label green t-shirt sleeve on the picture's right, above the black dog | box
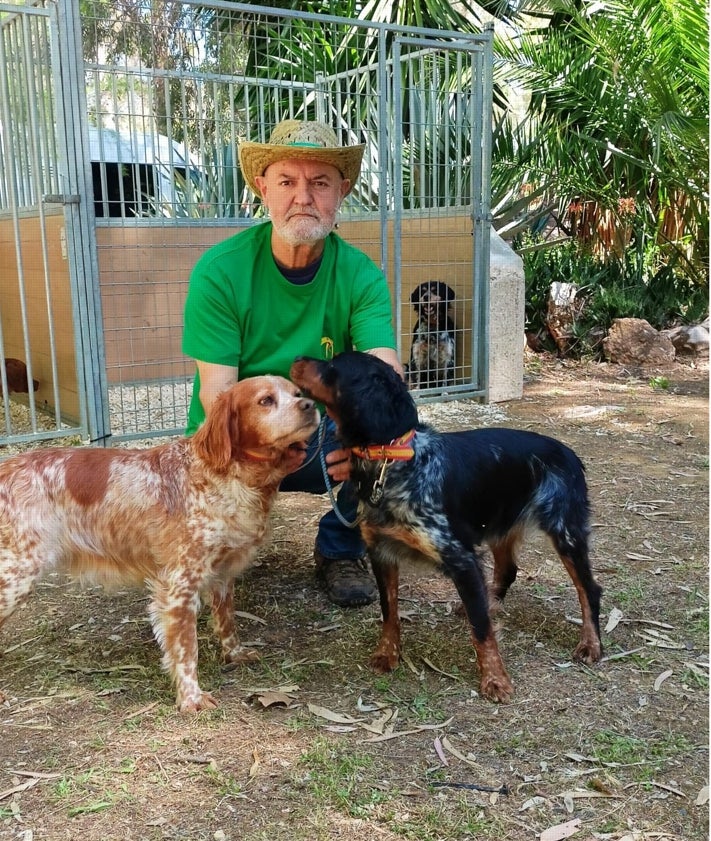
[350,255,397,351]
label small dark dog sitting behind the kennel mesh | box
[407,280,456,388]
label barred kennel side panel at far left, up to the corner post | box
[0,3,108,446]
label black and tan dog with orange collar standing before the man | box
[291,352,602,702]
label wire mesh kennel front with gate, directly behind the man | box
[0,0,491,446]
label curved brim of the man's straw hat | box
[238,141,365,198]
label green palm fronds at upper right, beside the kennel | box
[497,0,709,282]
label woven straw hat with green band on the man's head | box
[239,120,365,198]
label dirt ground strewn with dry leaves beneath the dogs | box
[0,357,709,841]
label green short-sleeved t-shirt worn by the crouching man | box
[183,222,396,434]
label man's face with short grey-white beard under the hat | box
[255,160,350,245]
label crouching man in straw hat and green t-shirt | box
[183,120,403,607]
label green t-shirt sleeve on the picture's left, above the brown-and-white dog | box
[182,259,242,367]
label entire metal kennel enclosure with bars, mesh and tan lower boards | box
[0,0,492,444]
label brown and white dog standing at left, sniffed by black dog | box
[0,376,319,712]
